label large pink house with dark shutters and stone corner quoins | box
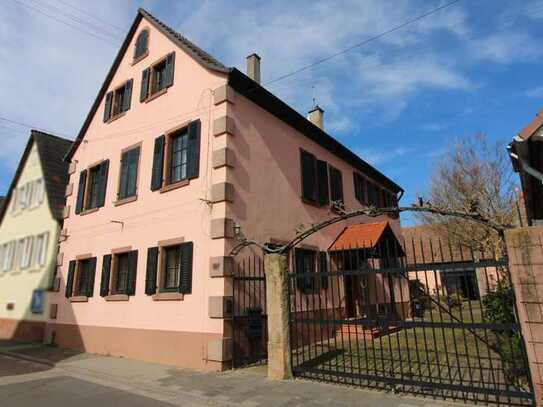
[46,9,402,370]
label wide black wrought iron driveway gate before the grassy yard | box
[289,242,533,405]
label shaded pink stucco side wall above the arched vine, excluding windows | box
[224,89,400,256]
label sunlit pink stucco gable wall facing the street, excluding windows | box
[49,20,230,342]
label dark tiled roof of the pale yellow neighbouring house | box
[0,130,72,222]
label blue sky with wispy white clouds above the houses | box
[0,0,543,223]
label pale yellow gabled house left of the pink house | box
[0,130,72,342]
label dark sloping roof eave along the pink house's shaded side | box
[228,68,403,193]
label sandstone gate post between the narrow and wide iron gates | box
[264,254,292,380]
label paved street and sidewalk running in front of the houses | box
[0,341,462,407]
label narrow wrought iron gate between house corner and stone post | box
[232,256,268,367]
